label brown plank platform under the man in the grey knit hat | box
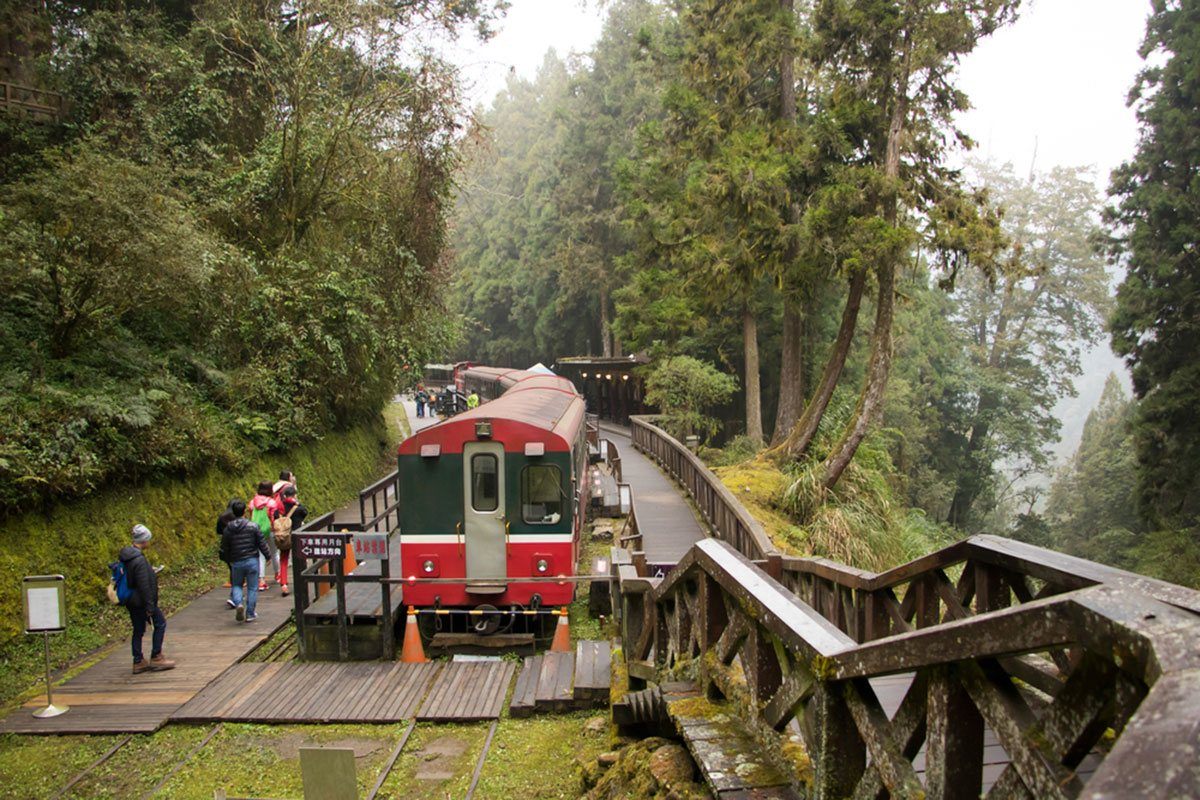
[0,585,292,734]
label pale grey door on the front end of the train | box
[462,441,508,594]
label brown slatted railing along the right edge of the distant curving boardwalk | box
[629,416,782,578]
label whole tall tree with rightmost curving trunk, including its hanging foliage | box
[814,0,1019,488]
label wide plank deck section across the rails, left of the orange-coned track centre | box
[172,662,440,723]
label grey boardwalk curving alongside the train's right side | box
[600,421,708,565]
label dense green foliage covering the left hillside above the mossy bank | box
[0,0,494,516]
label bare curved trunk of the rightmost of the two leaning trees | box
[824,34,912,489]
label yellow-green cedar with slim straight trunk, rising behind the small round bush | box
[640,0,794,441]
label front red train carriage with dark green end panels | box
[398,367,588,634]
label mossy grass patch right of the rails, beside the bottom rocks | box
[477,711,608,800]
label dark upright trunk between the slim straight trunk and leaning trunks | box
[770,0,804,446]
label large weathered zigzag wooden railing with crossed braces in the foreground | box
[616,536,1200,798]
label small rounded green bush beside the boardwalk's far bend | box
[646,355,738,438]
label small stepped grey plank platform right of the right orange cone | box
[509,640,612,717]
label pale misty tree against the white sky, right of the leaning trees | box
[944,163,1110,528]
